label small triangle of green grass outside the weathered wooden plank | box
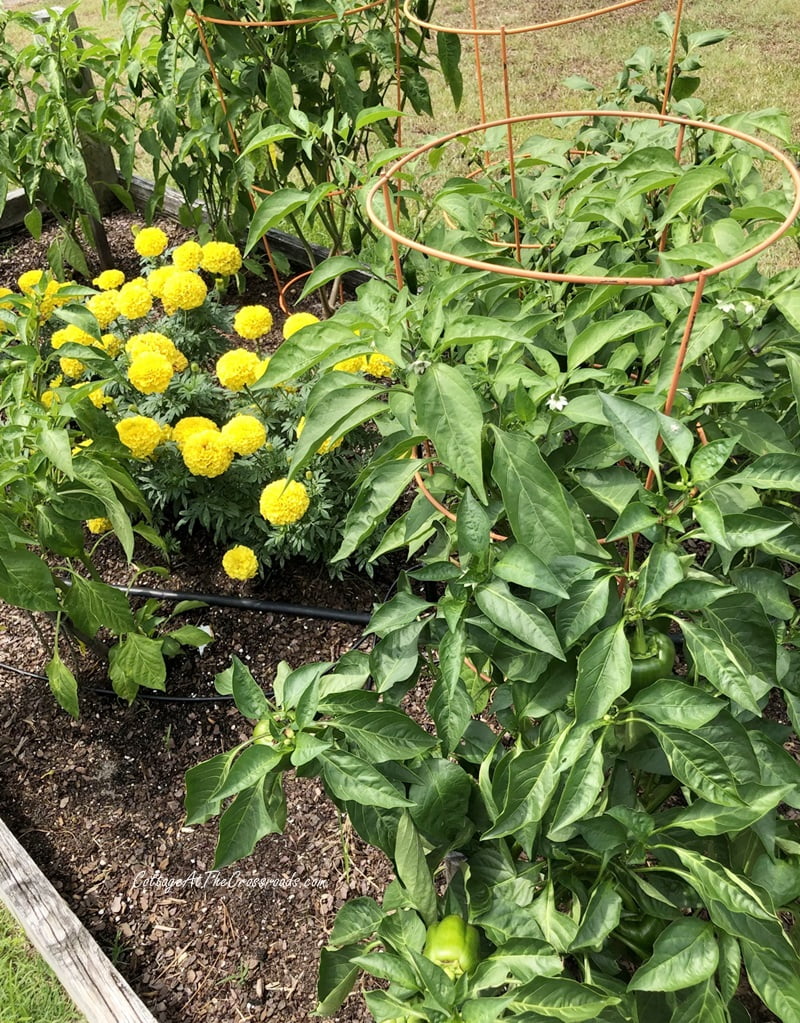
[0,903,84,1023]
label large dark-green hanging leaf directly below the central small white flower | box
[492,429,575,564]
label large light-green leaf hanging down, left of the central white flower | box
[414,363,486,502]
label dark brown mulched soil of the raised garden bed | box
[0,209,392,1023]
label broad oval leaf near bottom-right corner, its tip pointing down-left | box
[628,919,719,991]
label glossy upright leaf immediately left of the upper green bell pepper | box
[575,621,631,726]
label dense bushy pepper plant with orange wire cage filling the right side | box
[186,113,800,1023]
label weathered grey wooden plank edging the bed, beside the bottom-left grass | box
[0,818,158,1023]
